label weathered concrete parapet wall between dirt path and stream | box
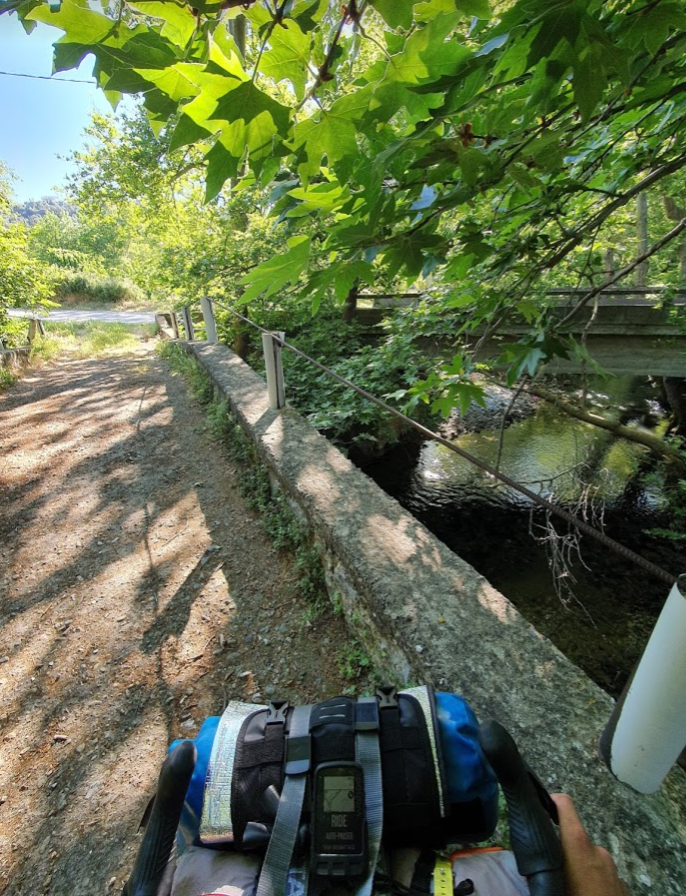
[182,343,686,896]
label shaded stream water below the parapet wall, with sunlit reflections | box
[365,377,686,695]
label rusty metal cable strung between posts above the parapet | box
[176,299,677,585]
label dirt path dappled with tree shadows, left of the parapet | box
[0,344,347,896]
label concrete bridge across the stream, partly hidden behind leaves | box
[357,287,686,378]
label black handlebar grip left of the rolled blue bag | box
[122,740,197,896]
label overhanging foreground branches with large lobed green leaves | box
[5,0,686,377]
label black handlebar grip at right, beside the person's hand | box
[479,721,565,896]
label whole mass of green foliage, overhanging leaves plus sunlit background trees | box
[3,0,686,456]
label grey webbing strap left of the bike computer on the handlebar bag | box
[256,706,312,896]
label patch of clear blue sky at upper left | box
[0,13,111,201]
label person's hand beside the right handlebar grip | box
[552,793,629,896]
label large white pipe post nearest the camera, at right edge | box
[600,576,686,793]
